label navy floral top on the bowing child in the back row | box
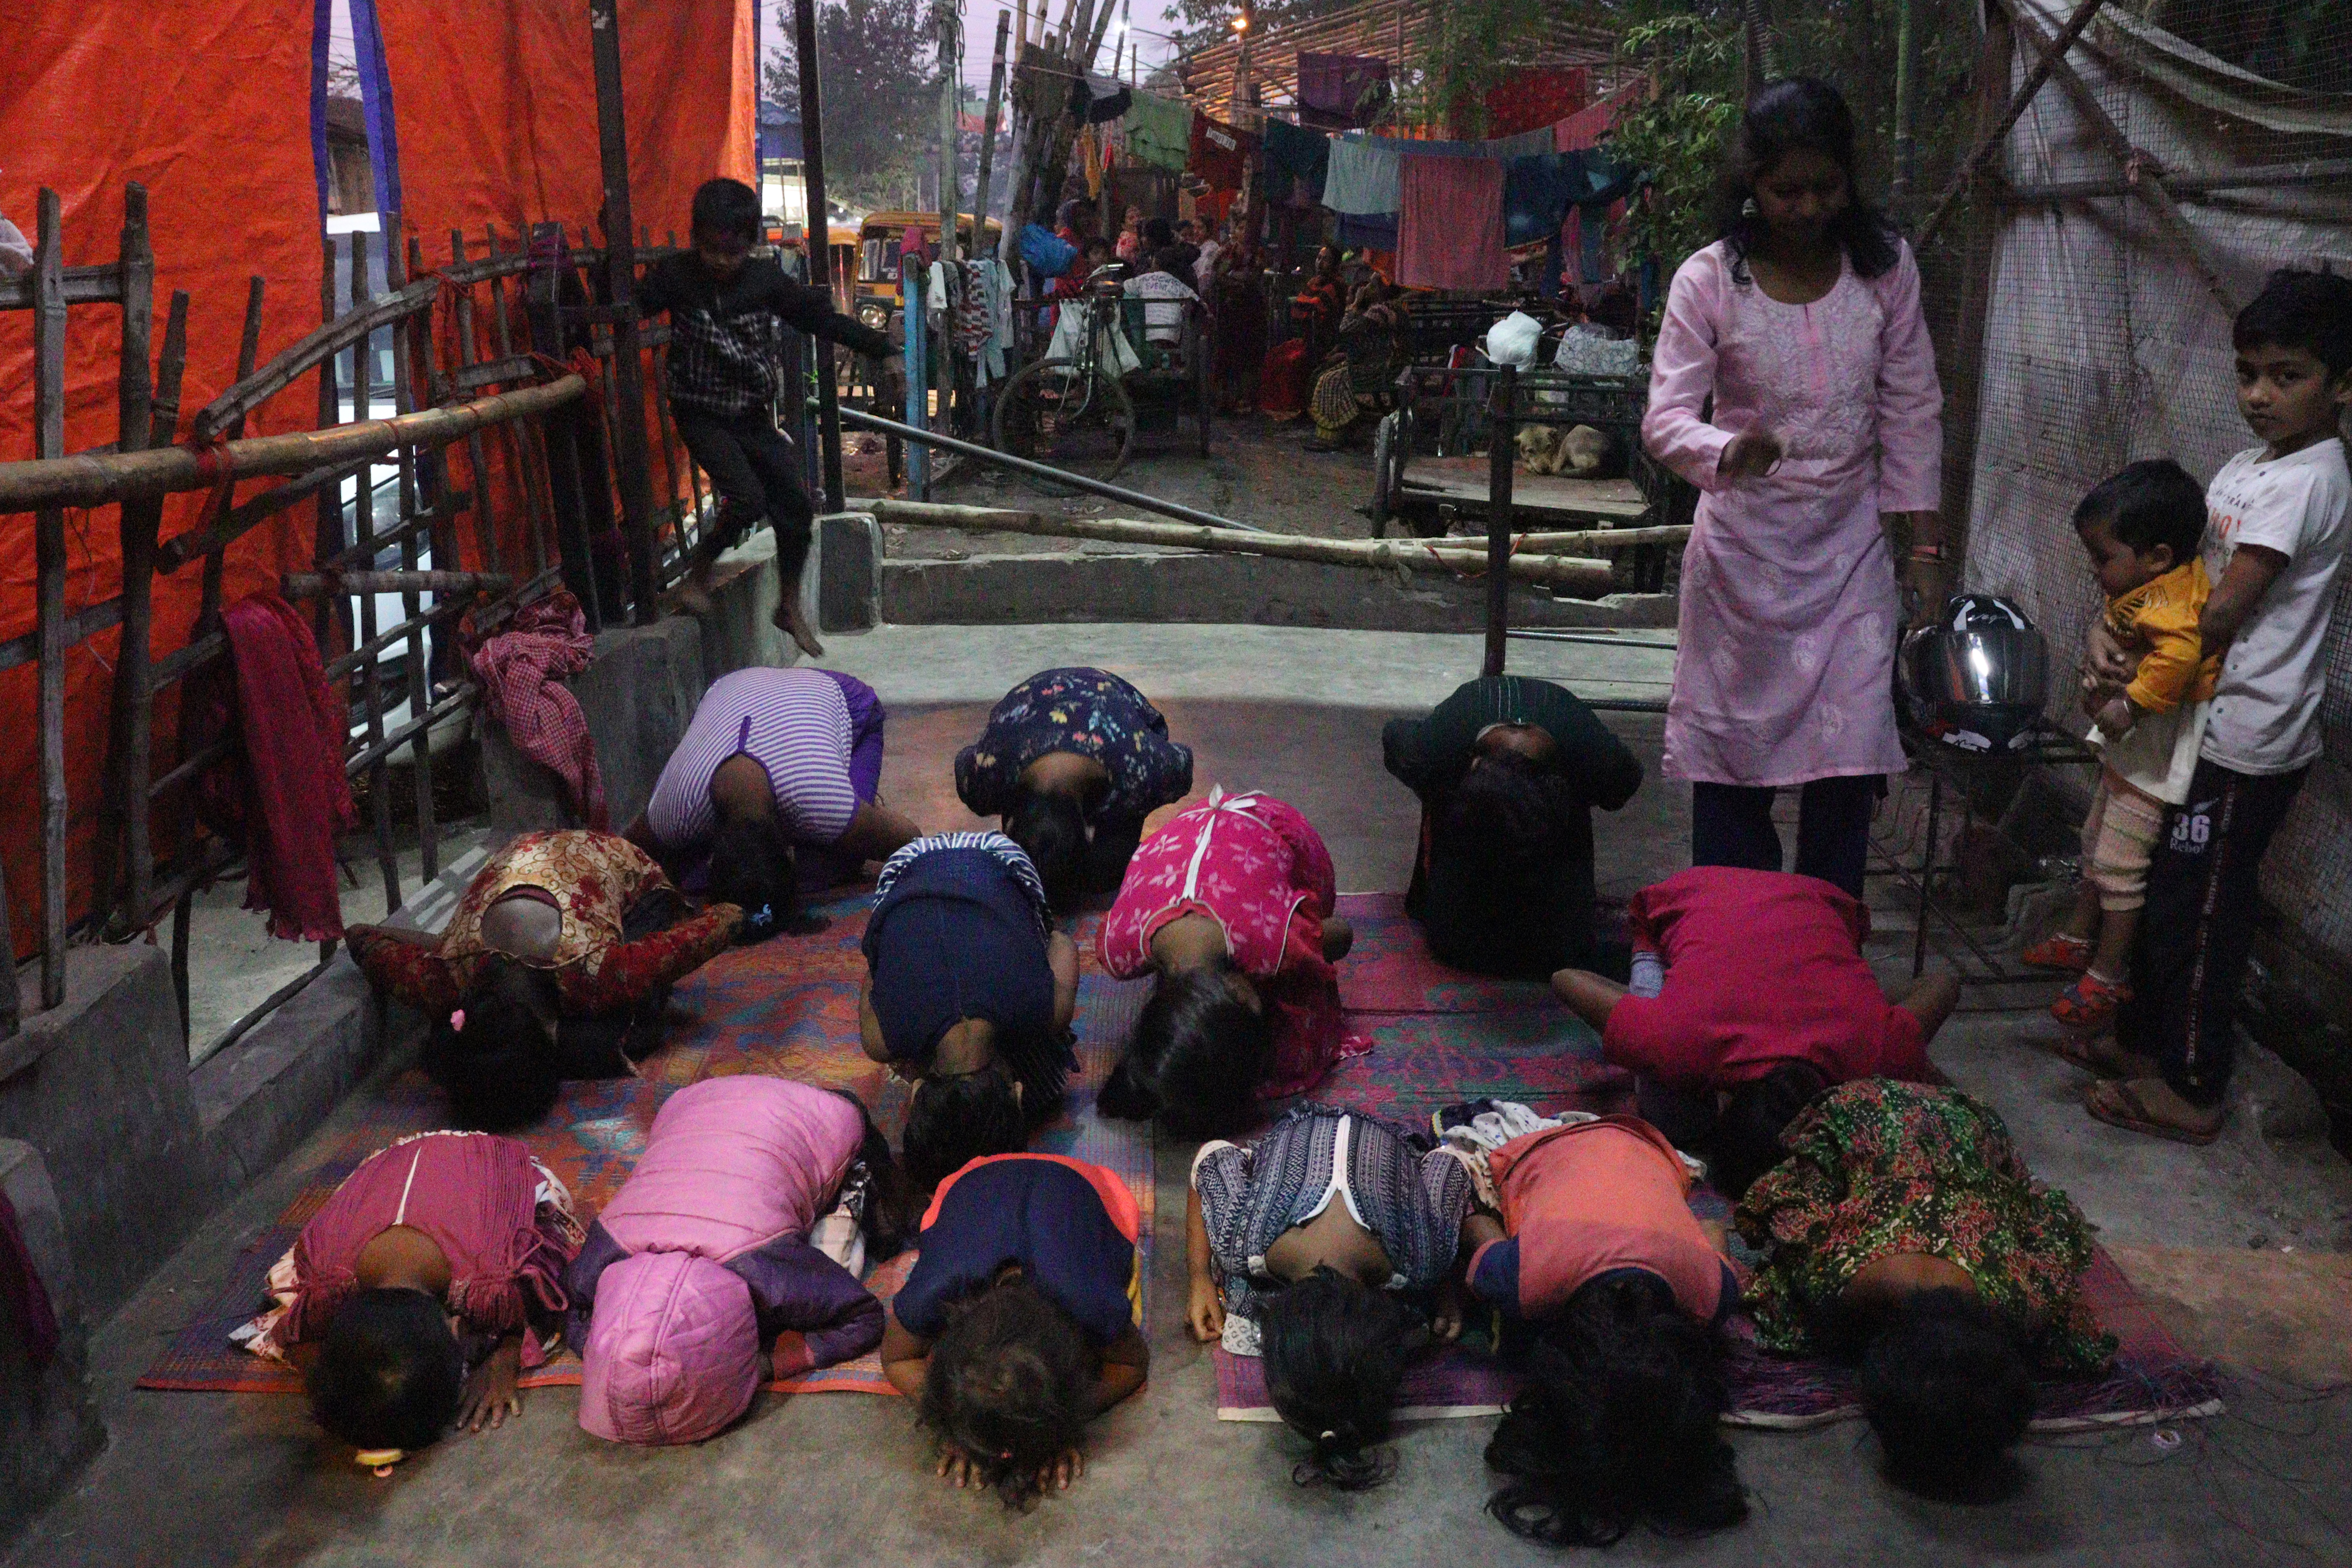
[955,668,1192,823]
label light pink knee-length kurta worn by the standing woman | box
[1642,242,1943,785]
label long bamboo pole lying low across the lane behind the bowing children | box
[851,498,1616,592]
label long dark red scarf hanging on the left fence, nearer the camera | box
[200,592,358,943]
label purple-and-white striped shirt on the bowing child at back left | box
[644,668,858,849]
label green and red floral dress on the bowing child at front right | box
[1736,1079,2114,1373]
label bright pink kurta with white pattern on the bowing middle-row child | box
[1096,790,1371,1100]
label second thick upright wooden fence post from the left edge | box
[89,181,162,931]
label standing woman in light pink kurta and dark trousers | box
[1642,78,1945,896]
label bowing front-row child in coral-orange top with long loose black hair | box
[1442,1103,1748,1547]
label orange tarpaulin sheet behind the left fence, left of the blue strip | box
[0,0,320,957]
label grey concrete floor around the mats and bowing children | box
[5,628,2352,1568]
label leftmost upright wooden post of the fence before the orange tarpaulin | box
[33,186,71,1009]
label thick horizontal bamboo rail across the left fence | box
[0,376,588,515]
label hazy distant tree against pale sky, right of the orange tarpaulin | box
[764,0,938,207]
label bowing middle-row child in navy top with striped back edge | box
[858,832,1077,1189]
